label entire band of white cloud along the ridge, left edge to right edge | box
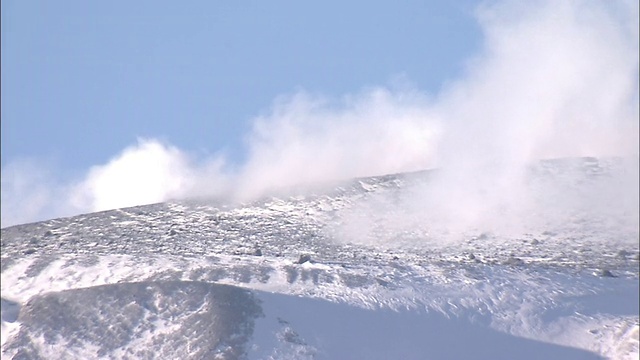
[2,0,640,227]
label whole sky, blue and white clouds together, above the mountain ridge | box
[1,0,638,227]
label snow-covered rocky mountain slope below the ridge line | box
[1,158,640,359]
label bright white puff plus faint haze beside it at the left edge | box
[2,139,228,227]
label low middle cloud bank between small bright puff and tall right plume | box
[240,88,440,196]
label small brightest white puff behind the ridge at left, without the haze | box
[71,139,230,211]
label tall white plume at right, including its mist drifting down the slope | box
[416,1,638,240]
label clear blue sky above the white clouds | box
[2,1,481,169]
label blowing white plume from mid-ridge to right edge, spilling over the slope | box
[234,1,638,242]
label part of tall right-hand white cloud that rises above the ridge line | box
[438,1,638,162]
